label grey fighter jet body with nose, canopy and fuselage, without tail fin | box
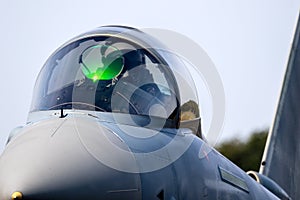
[0,18,299,200]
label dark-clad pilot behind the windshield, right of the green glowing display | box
[109,49,161,115]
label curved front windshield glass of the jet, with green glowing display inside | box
[31,36,180,119]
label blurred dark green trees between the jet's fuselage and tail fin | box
[217,131,268,171]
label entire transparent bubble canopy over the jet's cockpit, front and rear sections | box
[31,26,199,134]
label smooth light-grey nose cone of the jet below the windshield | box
[0,117,141,200]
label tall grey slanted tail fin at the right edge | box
[260,12,300,199]
